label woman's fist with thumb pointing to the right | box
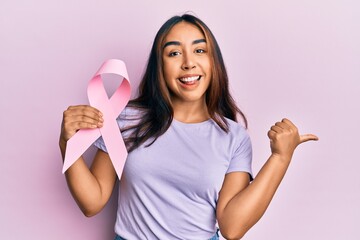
[268,118,318,160]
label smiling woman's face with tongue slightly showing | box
[162,22,211,103]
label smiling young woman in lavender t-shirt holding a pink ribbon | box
[60,15,317,239]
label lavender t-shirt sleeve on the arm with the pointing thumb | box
[226,129,253,180]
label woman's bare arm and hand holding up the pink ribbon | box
[59,106,116,217]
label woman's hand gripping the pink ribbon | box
[60,105,104,147]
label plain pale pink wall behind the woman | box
[0,0,360,240]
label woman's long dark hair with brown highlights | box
[123,14,247,152]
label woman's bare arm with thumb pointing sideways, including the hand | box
[216,119,318,239]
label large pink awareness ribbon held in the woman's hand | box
[62,59,131,179]
